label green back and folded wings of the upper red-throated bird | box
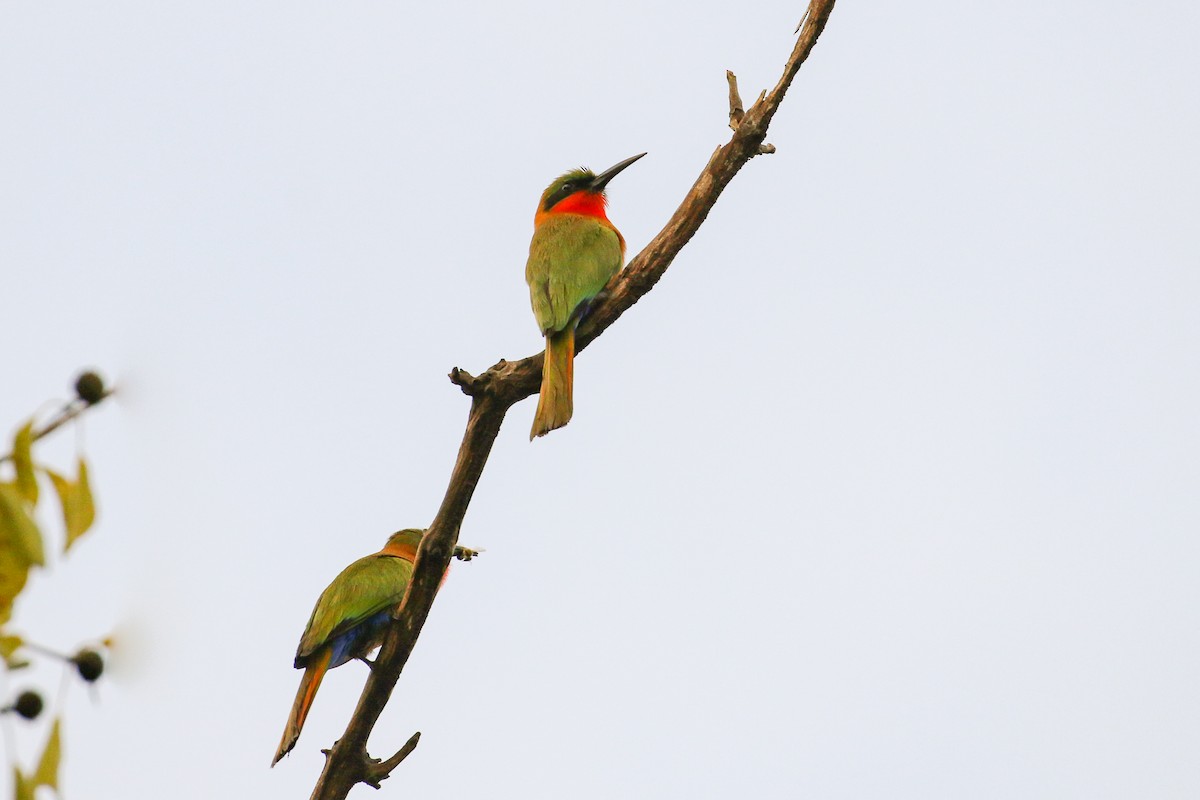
[526,213,622,333]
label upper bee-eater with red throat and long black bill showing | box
[526,152,646,439]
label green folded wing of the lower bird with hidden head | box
[296,553,413,660]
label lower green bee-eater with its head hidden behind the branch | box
[271,528,427,766]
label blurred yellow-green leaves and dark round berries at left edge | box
[0,372,110,800]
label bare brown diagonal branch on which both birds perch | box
[312,0,834,800]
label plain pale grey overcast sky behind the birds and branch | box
[0,0,1200,800]
